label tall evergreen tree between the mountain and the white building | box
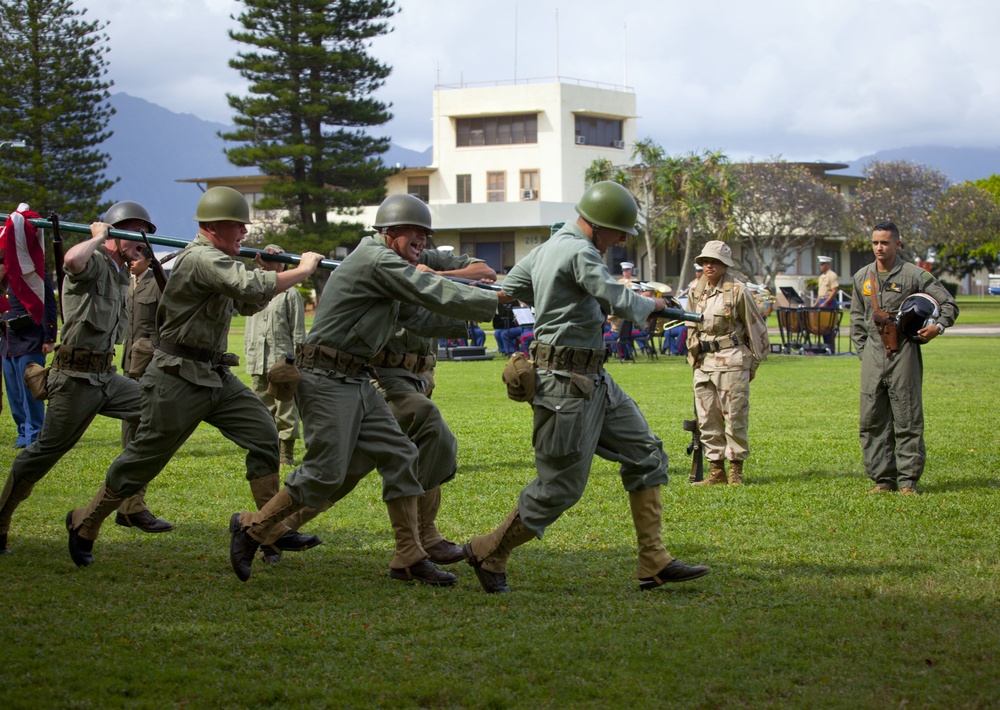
[222,0,396,252]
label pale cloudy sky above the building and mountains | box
[76,0,1000,160]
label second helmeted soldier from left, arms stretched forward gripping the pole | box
[66,187,323,567]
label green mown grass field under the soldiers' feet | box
[0,336,1000,708]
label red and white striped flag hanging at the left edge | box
[0,202,45,323]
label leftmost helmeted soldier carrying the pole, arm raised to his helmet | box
[0,202,173,551]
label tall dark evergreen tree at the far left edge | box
[0,0,117,222]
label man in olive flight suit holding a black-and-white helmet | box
[851,222,958,495]
